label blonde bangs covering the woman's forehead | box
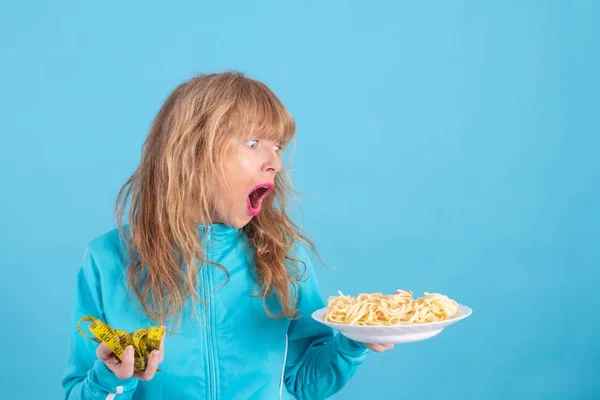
[224,79,296,147]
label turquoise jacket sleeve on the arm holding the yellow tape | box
[62,246,138,400]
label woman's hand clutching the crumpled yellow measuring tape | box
[96,335,165,381]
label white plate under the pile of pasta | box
[312,304,473,344]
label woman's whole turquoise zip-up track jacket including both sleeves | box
[62,224,369,400]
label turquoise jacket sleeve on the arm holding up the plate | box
[284,248,369,399]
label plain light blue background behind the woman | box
[0,0,600,400]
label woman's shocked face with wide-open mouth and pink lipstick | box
[213,138,282,228]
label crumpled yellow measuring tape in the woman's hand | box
[77,315,164,372]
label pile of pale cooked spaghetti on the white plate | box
[324,290,458,326]
